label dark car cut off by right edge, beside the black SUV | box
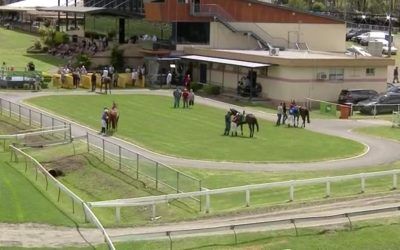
[357,92,400,115]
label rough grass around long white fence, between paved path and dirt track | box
[20,143,400,227]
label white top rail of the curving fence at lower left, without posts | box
[9,145,115,250]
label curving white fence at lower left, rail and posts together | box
[10,145,115,250]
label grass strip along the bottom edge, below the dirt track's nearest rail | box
[111,218,400,250]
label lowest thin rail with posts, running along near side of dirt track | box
[113,204,400,244]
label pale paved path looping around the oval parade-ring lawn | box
[0,90,400,171]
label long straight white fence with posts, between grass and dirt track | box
[89,169,400,220]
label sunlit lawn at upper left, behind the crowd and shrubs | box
[0,28,66,71]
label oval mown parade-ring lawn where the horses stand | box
[28,95,364,162]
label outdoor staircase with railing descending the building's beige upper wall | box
[190,3,289,50]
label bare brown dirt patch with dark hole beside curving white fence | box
[42,155,87,176]
